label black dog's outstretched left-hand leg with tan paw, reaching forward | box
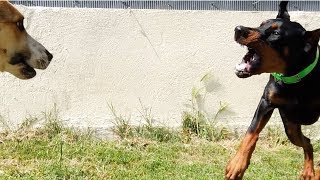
[225,97,274,179]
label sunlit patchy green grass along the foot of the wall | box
[0,106,312,180]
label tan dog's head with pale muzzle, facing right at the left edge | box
[0,0,52,79]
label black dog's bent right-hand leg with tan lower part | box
[279,108,314,180]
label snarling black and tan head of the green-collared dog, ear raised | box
[234,1,320,78]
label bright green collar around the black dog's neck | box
[271,48,319,84]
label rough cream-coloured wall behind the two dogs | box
[0,6,320,131]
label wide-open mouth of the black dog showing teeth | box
[235,47,261,78]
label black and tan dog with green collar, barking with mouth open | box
[225,1,320,179]
